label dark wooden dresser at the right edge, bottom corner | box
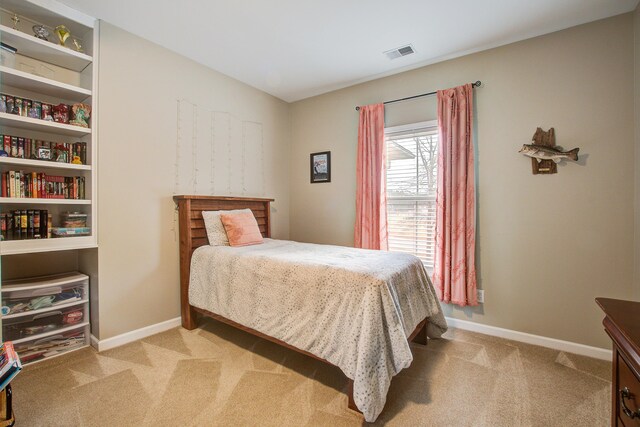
[596,298,640,427]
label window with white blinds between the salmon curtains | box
[385,121,438,270]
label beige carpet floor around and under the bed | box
[12,320,611,427]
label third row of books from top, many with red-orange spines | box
[0,171,86,200]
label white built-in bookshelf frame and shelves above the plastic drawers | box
[0,0,98,255]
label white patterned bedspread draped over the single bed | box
[189,239,447,422]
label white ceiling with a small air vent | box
[61,0,638,102]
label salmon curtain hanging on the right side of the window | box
[433,84,478,306]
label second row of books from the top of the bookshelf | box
[1,135,87,165]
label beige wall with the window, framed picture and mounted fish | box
[290,14,634,347]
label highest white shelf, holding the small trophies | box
[0,25,93,72]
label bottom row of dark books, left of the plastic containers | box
[0,209,53,240]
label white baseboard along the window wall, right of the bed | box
[446,317,612,360]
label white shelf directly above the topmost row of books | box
[0,65,91,102]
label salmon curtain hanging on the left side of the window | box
[354,104,389,250]
